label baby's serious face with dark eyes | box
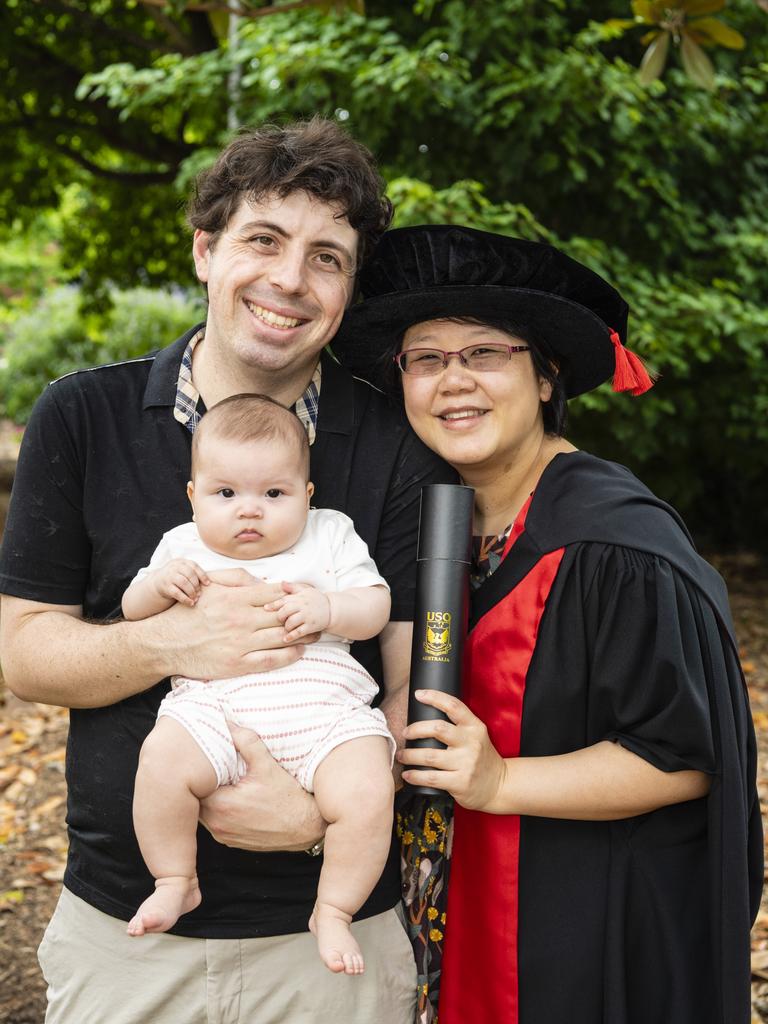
[187,436,313,559]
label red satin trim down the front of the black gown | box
[439,499,565,1024]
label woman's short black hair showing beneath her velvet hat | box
[385,316,568,437]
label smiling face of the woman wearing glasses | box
[401,319,552,480]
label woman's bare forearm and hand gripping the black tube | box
[397,690,711,820]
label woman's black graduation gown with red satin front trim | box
[439,453,763,1024]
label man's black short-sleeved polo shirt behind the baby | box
[0,329,455,938]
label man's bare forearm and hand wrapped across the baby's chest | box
[0,583,302,708]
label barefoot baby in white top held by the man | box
[123,394,395,974]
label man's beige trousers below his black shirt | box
[38,889,417,1024]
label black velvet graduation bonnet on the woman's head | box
[332,224,629,398]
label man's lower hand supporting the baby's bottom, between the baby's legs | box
[200,724,326,852]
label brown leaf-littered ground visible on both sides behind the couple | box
[0,432,768,1024]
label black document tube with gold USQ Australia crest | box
[407,483,475,795]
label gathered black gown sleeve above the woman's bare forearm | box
[585,547,728,773]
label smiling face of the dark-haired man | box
[193,193,357,374]
